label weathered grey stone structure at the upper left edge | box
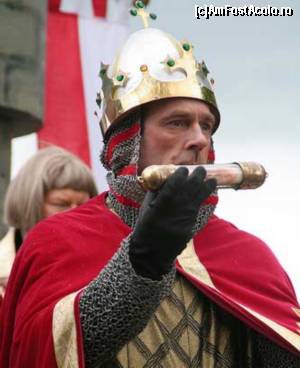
[0,0,47,236]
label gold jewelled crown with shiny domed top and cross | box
[97,1,220,135]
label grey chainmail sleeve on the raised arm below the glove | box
[79,236,175,368]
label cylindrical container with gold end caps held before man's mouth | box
[138,162,267,190]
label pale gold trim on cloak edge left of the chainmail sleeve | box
[52,291,79,368]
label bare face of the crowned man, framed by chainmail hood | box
[139,98,216,172]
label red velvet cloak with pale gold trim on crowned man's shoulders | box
[0,193,300,368]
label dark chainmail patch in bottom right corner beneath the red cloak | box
[253,332,300,368]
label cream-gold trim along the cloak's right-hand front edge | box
[177,240,300,351]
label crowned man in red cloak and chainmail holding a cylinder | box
[0,2,300,368]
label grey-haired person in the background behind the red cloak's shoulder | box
[0,147,97,300]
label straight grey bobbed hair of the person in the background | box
[4,146,97,236]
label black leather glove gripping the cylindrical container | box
[129,167,216,280]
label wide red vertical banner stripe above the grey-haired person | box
[38,12,90,165]
